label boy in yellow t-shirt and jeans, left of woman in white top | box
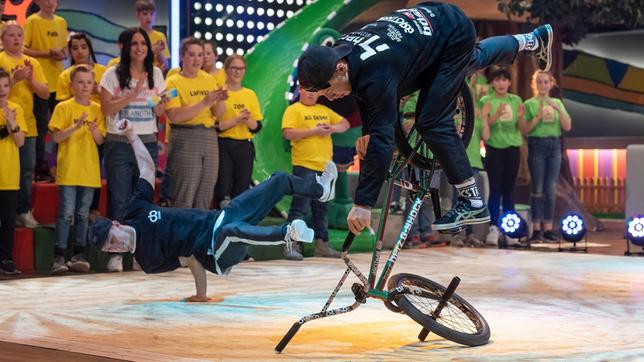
[49,65,106,274]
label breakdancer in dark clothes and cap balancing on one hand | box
[90,120,337,302]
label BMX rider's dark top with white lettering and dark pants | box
[336,3,519,207]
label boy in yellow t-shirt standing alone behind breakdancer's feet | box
[282,88,349,260]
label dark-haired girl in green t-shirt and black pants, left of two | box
[481,69,526,245]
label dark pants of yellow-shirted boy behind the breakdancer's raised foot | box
[288,166,329,241]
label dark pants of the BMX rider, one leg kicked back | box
[416,7,519,185]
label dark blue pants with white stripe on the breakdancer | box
[211,172,322,273]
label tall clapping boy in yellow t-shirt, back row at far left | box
[0,21,49,228]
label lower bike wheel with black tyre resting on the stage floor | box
[388,273,490,347]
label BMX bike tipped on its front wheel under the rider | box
[275,82,490,353]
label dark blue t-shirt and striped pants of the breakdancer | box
[122,172,323,274]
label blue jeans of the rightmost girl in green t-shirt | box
[528,137,561,223]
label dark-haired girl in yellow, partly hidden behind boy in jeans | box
[56,33,107,104]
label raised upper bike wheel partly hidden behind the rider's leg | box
[395,81,474,170]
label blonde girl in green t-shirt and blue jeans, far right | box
[524,70,571,242]
